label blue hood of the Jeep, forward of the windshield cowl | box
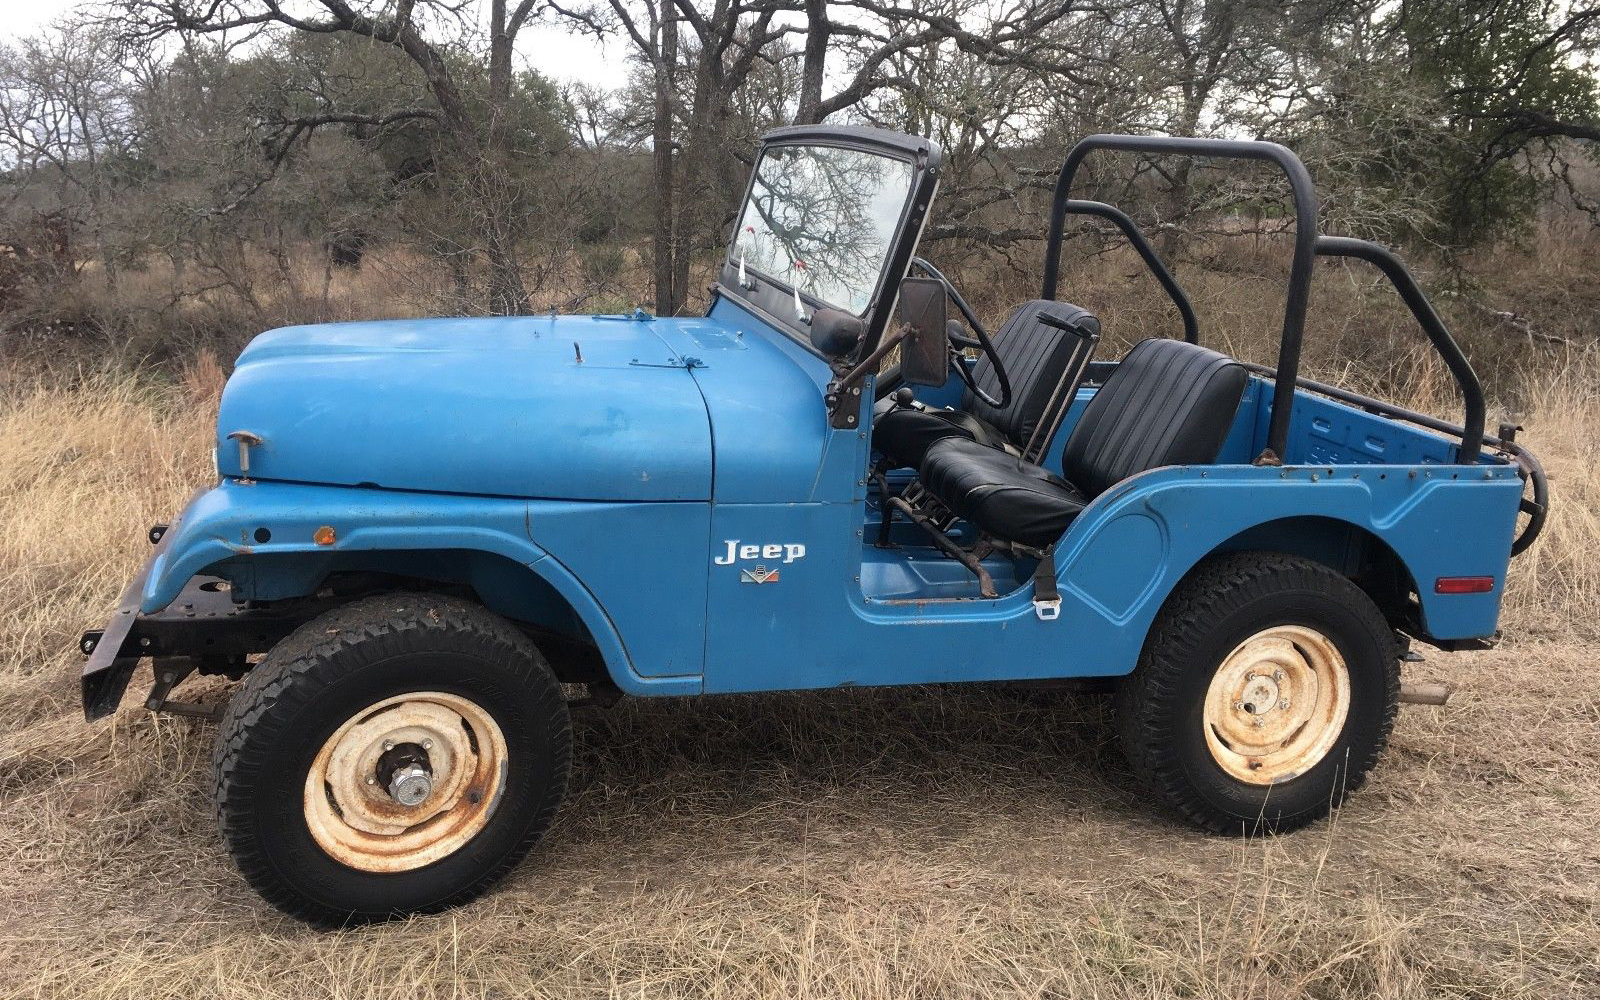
[218,317,712,501]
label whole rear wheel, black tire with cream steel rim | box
[1117,552,1400,834]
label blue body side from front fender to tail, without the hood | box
[142,388,1522,693]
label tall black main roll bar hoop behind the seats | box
[1038,134,1317,464]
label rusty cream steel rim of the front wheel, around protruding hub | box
[304,691,507,872]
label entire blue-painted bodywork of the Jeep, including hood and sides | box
[142,302,1522,694]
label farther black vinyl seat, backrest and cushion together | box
[872,299,1099,469]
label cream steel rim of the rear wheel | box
[1205,626,1350,786]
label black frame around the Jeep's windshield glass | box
[712,125,942,362]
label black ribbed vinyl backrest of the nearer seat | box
[1061,339,1250,499]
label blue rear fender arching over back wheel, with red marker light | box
[1056,466,1522,640]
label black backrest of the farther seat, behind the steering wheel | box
[962,299,1099,448]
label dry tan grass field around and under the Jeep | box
[0,312,1600,1000]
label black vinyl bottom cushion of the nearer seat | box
[920,437,1088,549]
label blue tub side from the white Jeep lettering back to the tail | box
[706,466,1522,691]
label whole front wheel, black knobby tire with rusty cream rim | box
[213,594,571,925]
